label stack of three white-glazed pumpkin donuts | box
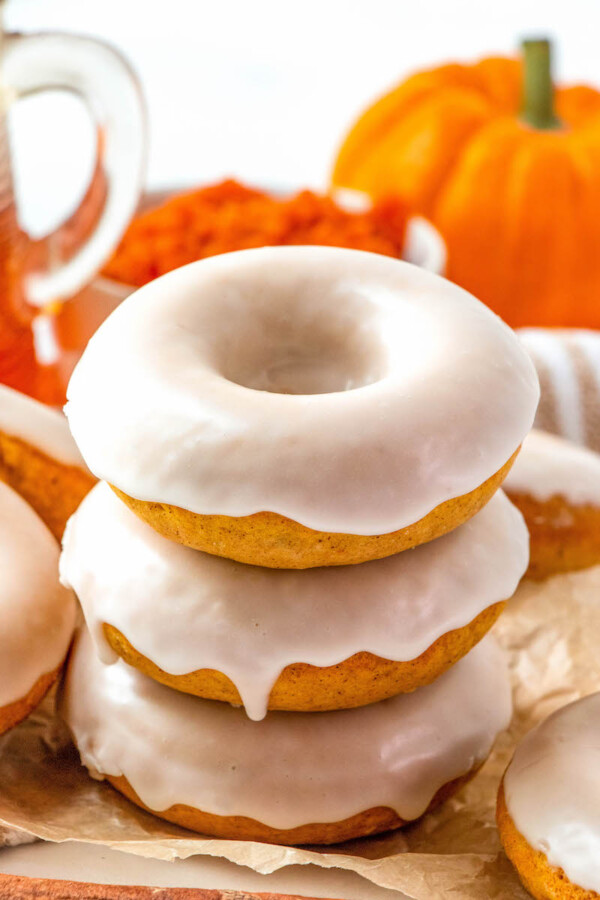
[61,247,538,844]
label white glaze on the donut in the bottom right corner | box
[504,693,600,893]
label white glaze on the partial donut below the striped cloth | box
[504,431,600,506]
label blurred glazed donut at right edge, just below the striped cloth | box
[505,431,600,580]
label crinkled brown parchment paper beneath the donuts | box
[0,567,600,900]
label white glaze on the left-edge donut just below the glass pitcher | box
[0,384,85,467]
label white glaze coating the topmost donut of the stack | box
[66,247,538,534]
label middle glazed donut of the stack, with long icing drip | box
[60,484,528,719]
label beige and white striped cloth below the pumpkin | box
[517,328,600,452]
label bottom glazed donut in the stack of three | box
[60,631,511,844]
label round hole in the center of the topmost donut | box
[220,298,387,394]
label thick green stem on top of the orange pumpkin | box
[521,39,561,129]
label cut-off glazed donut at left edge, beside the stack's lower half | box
[0,482,76,734]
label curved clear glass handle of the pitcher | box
[3,32,146,307]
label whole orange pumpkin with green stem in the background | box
[332,41,600,328]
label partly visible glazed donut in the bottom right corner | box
[497,693,600,900]
